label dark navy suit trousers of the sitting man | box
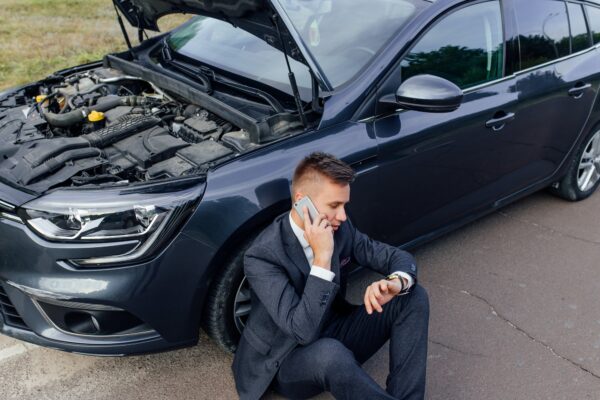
[274,285,429,400]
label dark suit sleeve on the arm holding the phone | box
[244,242,339,345]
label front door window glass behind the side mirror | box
[401,1,504,89]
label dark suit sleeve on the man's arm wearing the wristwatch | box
[347,220,417,283]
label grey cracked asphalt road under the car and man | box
[0,193,600,400]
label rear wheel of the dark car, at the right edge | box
[550,129,600,201]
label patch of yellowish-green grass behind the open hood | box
[0,0,189,91]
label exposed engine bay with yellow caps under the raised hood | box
[0,67,297,192]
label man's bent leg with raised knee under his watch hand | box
[323,285,429,400]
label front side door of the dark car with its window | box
[373,0,517,243]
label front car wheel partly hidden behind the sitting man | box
[203,243,251,353]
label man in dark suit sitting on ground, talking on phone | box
[232,153,429,399]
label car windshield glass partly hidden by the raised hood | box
[167,0,431,94]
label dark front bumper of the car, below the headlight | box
[0,205,209,355]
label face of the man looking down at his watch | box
[295,178,350,231]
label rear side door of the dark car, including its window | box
[507,0,600,194]
